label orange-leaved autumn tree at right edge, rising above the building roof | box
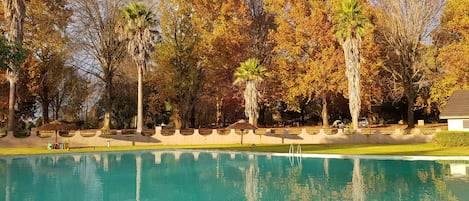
[430,0,469,110]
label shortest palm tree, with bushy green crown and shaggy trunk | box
[234,59,269,126]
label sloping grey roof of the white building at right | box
[440,90,469,119]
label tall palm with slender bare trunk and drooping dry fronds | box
[120,2,155,133]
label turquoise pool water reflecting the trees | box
[0,150,469,201]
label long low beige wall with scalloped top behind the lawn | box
[0,127,439,147]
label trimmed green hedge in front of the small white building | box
[435,131,469,147]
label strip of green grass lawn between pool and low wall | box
[0,143,469,156]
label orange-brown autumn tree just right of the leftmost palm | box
[24,0,72,123]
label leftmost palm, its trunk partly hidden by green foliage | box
[3,0,26,131]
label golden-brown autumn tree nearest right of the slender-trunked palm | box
[150,0,206,128]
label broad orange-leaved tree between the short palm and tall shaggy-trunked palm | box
[266,1,344,127]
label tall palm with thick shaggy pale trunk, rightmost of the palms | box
[335,0,368,129]
